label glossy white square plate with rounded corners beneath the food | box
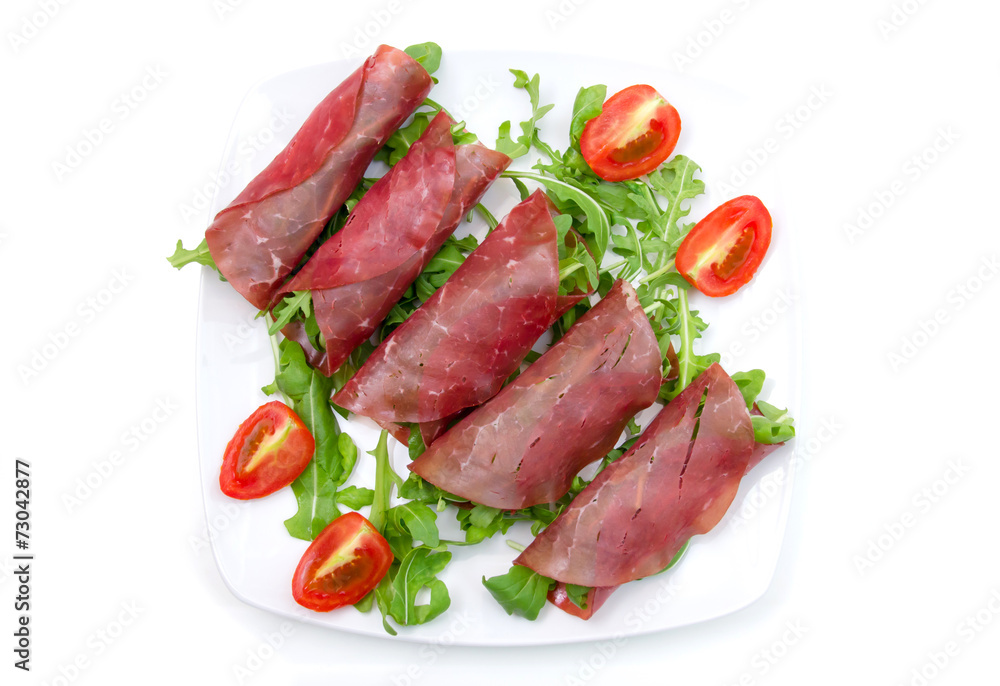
[197,52,800,646]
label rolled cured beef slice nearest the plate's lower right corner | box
[514,364,754,586]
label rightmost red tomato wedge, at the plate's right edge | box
[676,195,771,298]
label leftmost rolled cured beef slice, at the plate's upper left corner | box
[205,45,432,309]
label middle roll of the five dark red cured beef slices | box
[333,191,583,444]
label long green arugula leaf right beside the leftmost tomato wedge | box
[265,340,358,541]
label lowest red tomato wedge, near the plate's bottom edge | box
[292,512,392,612]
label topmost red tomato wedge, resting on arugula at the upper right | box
[580,84,681,181]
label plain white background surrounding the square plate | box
[0,0,1000,686]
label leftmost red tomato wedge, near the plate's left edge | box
[219,400,316,500]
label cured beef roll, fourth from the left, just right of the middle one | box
[409,281,661,510]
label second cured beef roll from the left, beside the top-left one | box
[278,113,510,376]
